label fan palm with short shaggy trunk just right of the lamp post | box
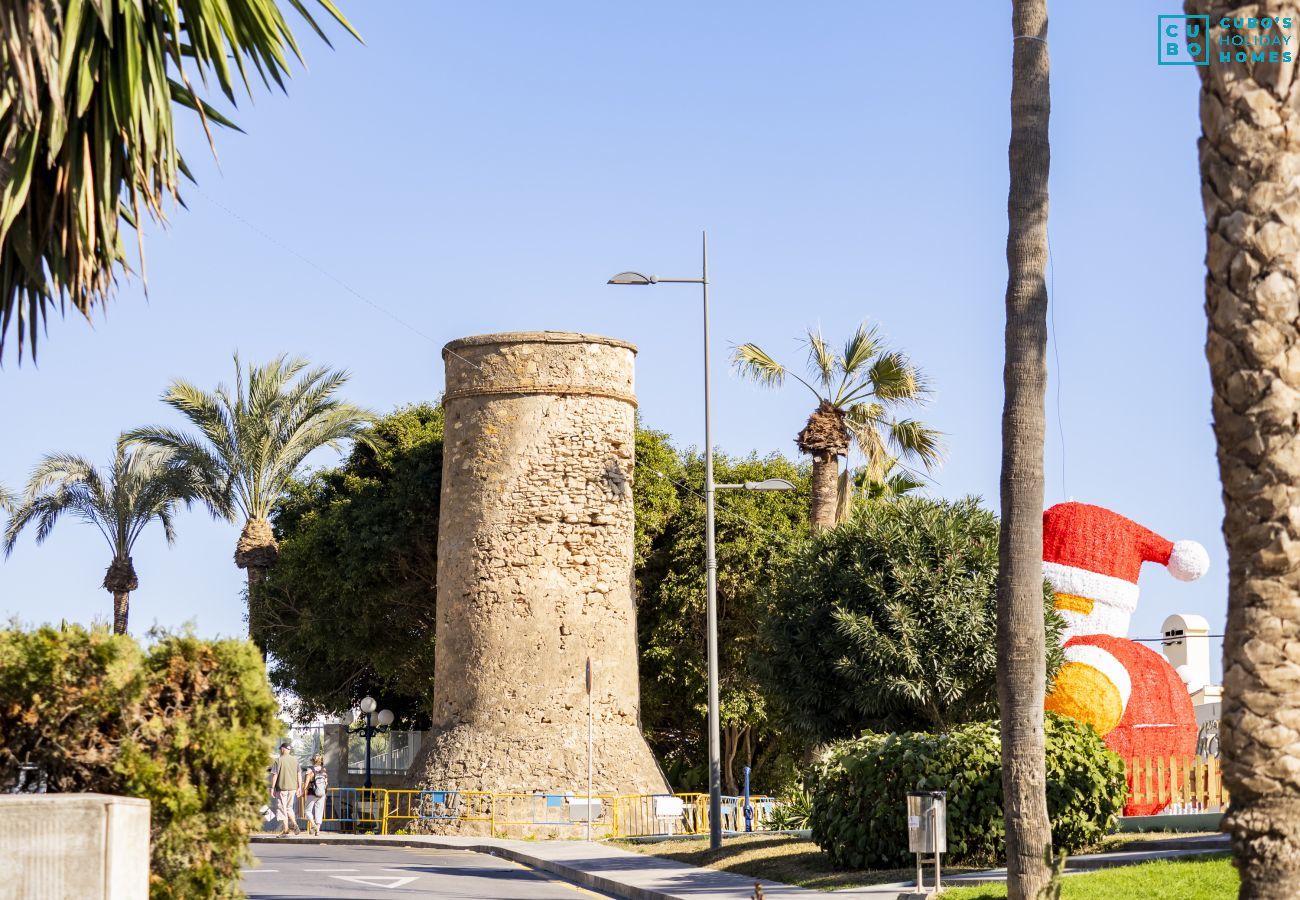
[732,324,941,532]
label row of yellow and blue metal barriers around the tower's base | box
[294,788,779,838]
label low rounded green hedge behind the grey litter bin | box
[810,714,1127,869]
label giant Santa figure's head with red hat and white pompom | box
[1043,503,1209,636]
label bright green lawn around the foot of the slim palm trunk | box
[943,854,1240,900]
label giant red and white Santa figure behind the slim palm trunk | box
[1043,503,1209,815]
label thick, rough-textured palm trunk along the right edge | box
[1187,0,1300,900]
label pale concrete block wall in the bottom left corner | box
[0,793,150,900]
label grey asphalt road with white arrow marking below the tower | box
[243,843,606,900]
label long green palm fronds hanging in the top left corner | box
[0,0,356,355]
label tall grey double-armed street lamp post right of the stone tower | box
[607,232,794,849]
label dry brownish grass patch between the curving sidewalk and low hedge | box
[615,835,971,896]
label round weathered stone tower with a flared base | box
[423,332,668,793]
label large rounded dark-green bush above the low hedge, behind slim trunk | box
[758,497,1062,743]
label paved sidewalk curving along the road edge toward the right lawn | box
[252,832,1227,900]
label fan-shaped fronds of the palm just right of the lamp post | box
[732,324,943,480]
